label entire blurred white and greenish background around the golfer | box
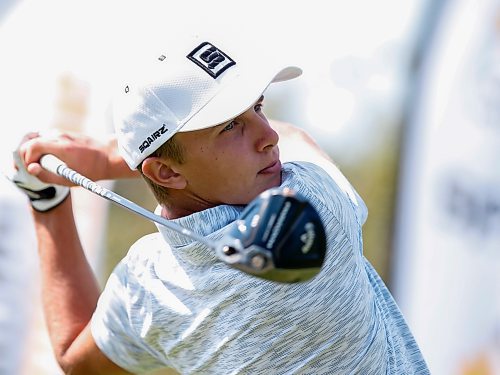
[0,0,500,375]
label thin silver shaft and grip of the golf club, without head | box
[40,155,215,249]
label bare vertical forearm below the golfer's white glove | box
[33,197,99,368]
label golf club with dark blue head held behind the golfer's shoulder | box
[40,155,326,283]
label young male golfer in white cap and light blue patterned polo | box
[10,33,428,375]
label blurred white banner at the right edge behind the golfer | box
[393,0,500,375]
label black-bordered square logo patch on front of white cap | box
[187,42,236,78]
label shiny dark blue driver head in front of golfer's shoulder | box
[218,188,326,283]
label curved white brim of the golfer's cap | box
[182,66,302,132]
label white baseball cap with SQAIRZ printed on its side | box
[113,36,302,169]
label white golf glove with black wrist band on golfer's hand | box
[9,150,69,212]
